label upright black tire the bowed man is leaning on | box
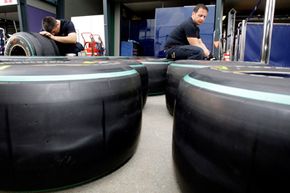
[4,32,60,56]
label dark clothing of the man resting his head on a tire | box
[56,19,77,56]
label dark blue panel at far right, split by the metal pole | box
[245,23,290,67]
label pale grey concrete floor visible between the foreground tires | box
[0,95,180,193]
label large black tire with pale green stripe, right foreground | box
[173,66,290,193]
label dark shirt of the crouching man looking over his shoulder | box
[164,17,200,49]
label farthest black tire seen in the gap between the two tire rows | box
[140,59,171,96]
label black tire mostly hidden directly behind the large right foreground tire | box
[165,60,262,115]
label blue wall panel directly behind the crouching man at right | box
[154,5,215,57]
